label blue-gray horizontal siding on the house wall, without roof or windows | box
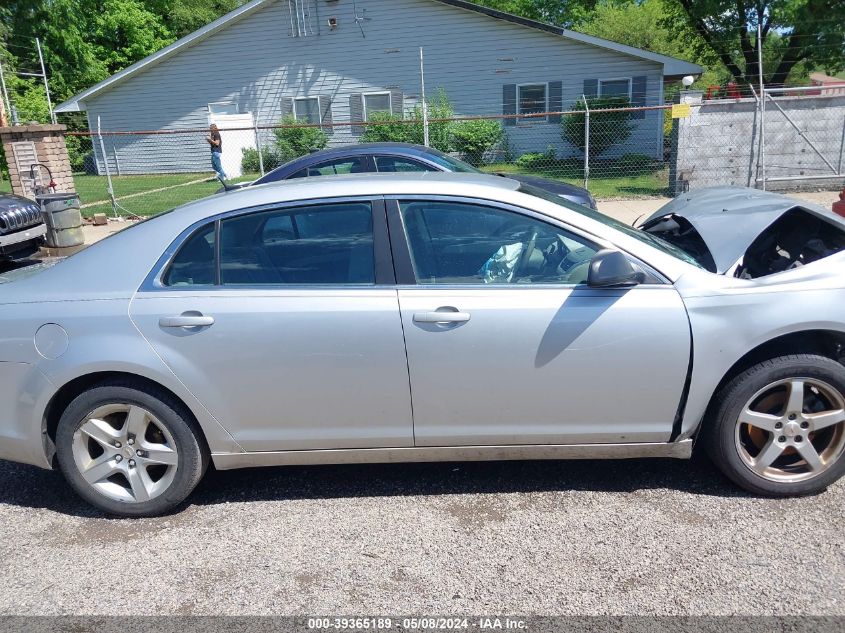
[85,0,663,173]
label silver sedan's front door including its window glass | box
[388,198,690,446]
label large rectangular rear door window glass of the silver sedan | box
[220,202,375,285]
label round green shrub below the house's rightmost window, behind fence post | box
[561,97,634,157]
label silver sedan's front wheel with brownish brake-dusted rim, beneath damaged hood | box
[701,354,845,497]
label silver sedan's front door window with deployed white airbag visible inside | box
[400,201,599,285]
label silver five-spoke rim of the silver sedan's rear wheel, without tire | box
[73,403,179,503]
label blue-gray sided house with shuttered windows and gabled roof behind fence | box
[56,0,701,173]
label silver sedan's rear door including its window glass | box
[130,199,413,451]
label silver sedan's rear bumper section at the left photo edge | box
[0,361,56,468]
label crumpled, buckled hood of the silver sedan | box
[639,187,845,278]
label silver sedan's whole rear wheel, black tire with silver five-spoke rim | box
[56,382,209,517]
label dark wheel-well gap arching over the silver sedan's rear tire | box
[43,371,208,467]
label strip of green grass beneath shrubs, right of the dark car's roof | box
[482,163,669,199]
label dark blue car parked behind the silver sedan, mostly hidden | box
[237,143,596,209]
